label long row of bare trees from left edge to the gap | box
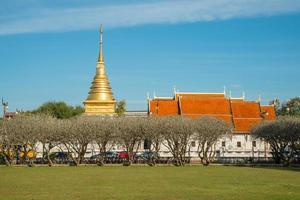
[0,115,231,166]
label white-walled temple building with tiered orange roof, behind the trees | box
[148,90,276,162]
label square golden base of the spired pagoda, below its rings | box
[84,101,116,116]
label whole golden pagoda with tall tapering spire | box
[83,25,116,115]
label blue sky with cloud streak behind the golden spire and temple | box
[0,0,300,111]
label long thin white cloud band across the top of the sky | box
[0,0,300,35]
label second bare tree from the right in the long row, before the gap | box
[161,117,193,166]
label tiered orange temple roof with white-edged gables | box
[149,92,276,133]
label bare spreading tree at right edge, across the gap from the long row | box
[252,117,300,165]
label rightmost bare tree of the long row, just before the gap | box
[194,117,231,166]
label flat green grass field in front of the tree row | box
[0,166,300,200]
